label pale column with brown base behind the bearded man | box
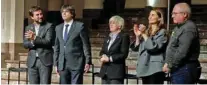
[1,0,24,60]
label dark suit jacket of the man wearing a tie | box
[54,21,91,70]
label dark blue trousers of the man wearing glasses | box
[171,64,201,84]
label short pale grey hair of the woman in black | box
[109,15,124,30]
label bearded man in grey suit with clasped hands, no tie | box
[23,6,54,84]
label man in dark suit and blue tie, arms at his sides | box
[54,5,91,84]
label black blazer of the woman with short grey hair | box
[100,32,130,79]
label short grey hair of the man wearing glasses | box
[175,3,191,18]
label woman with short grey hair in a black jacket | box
[100,16,130,84]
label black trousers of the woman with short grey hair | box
[102,76,124,84]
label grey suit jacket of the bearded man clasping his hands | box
[23,22,54,67]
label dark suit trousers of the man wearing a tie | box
[59,65,83,84]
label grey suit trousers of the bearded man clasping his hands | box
[28,58,52,84]
